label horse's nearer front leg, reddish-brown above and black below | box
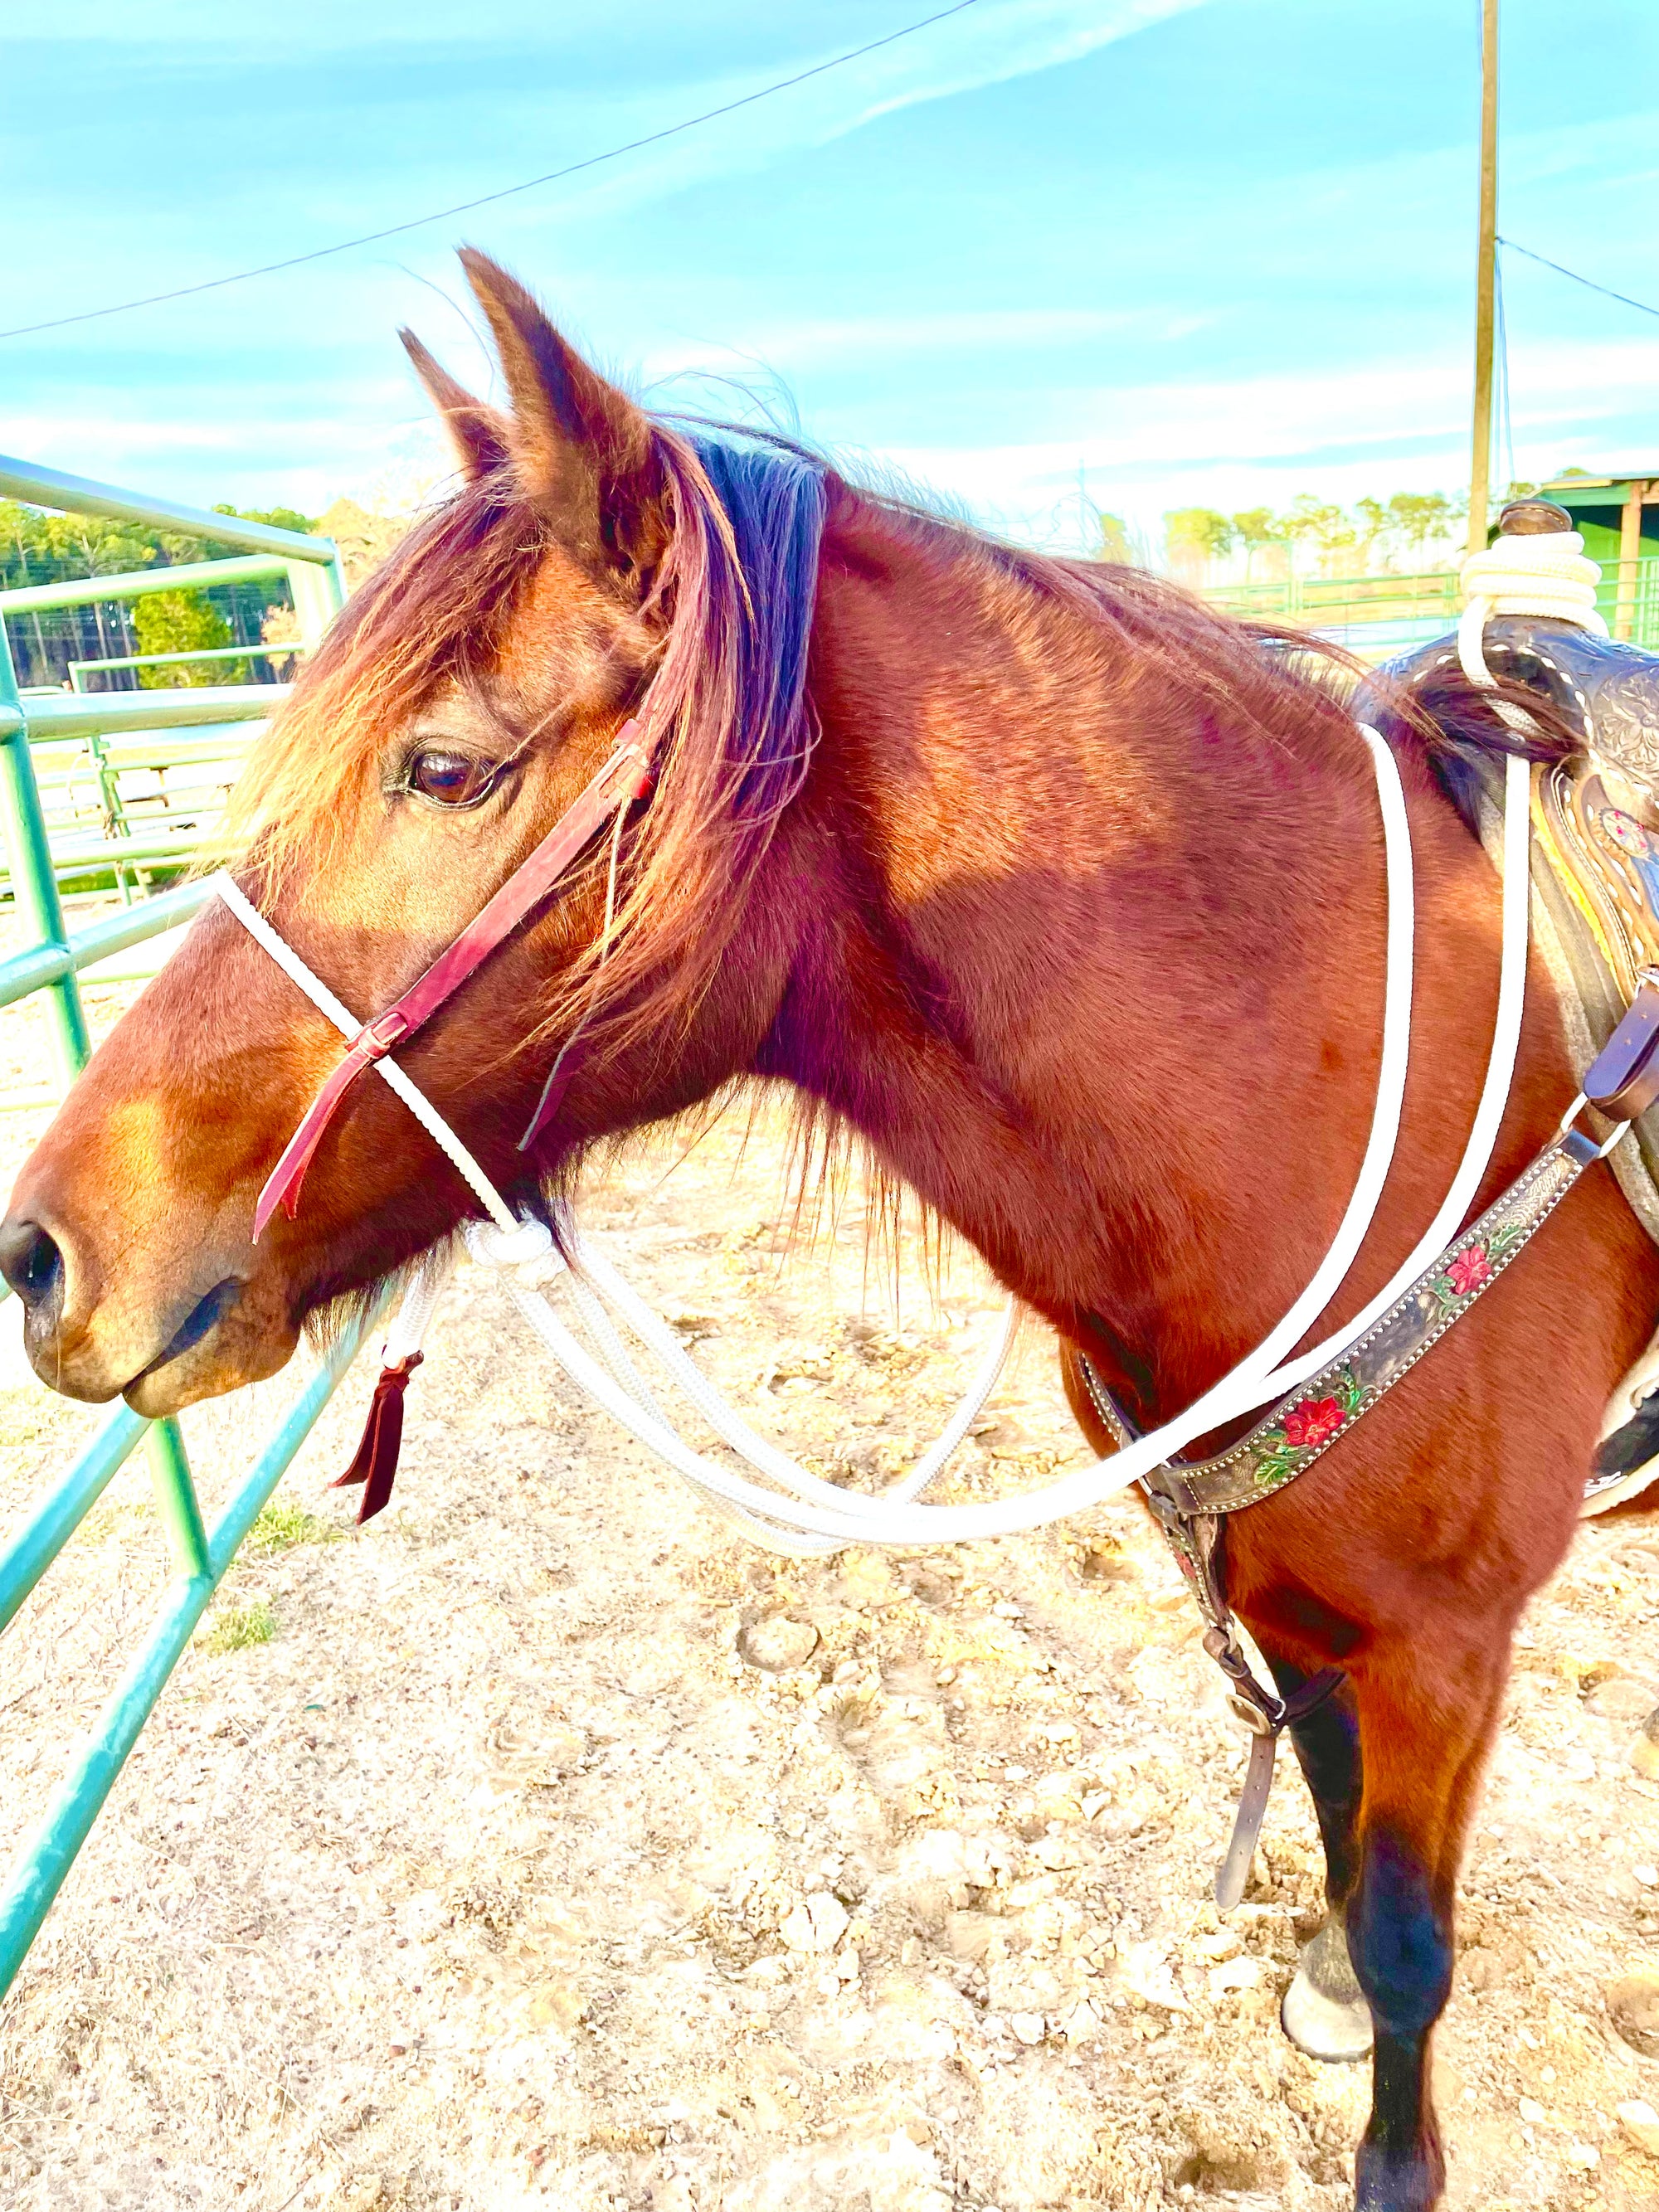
[1347,1650,1504,2212]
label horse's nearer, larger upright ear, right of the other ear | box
[460,246,666,577]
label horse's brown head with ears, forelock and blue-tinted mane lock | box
[0,255,823,1416]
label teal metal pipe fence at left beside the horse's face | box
[0,460,367,1996]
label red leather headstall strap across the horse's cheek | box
[255,721,654,1239]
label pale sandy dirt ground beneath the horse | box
[0,955,1659,2212]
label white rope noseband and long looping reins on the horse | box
[212,694,1529,1555]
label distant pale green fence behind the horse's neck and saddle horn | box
[1205,560,1659,659]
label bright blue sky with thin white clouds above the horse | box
[0,0,1659,542]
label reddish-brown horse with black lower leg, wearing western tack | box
[0,256,1659,2212]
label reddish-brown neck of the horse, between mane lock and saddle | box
[757,498,1570,1398]
